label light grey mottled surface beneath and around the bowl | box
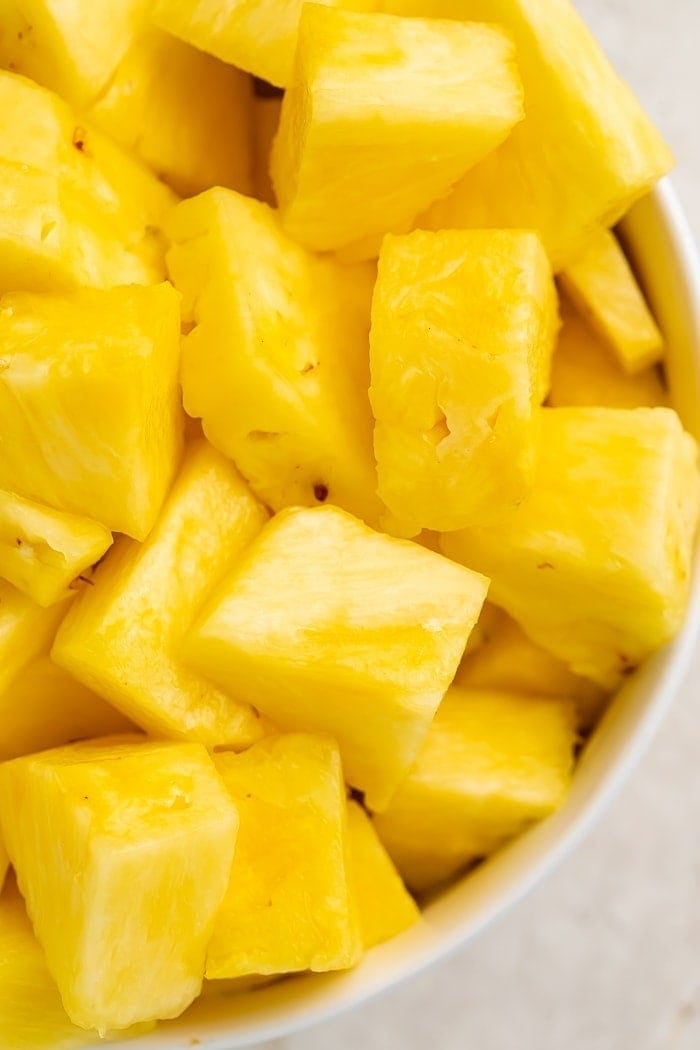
[266,0,700,1050]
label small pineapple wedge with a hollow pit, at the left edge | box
[0,491,112,605]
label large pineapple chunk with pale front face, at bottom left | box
[0,737,238,1031]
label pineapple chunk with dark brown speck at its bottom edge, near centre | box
[168,189,380,523]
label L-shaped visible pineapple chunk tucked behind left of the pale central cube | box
[52,441,268,748]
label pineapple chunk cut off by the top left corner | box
[0,0,150,106]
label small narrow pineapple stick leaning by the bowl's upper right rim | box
[560,230,663,374]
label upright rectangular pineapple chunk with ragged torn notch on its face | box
[369,230,557,536]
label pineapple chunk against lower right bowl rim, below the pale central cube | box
[375,687,576,893]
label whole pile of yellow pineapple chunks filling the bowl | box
[0,0,700,1047]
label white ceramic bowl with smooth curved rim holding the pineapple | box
[111,181,700,1050]
